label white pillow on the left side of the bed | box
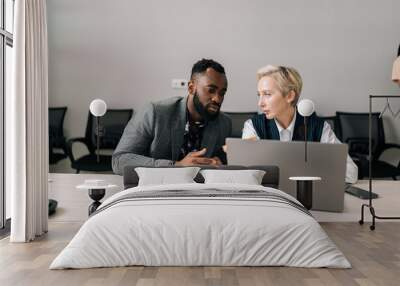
[135,167,200,186]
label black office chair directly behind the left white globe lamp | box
[67,109,133,174]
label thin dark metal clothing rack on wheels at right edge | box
[358,95,400,230]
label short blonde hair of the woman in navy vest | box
[257,65,303,106]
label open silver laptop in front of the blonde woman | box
[226,138,347,212]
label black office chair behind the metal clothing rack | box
[336,112,400,180]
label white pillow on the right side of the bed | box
[200,170,265,185]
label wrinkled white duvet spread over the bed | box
[50,184,351,269]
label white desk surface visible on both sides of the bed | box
[49,173,400,222]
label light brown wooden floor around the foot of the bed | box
[0,222,400,286]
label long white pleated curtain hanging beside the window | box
[6,0,49,242]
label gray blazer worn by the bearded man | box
[112,97,232,175]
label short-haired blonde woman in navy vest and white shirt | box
[242,65,358,183]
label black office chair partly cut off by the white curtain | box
[49,107,67,164]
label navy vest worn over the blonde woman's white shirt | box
[251,111,325,142]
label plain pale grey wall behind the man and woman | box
[47,0,400,142]
